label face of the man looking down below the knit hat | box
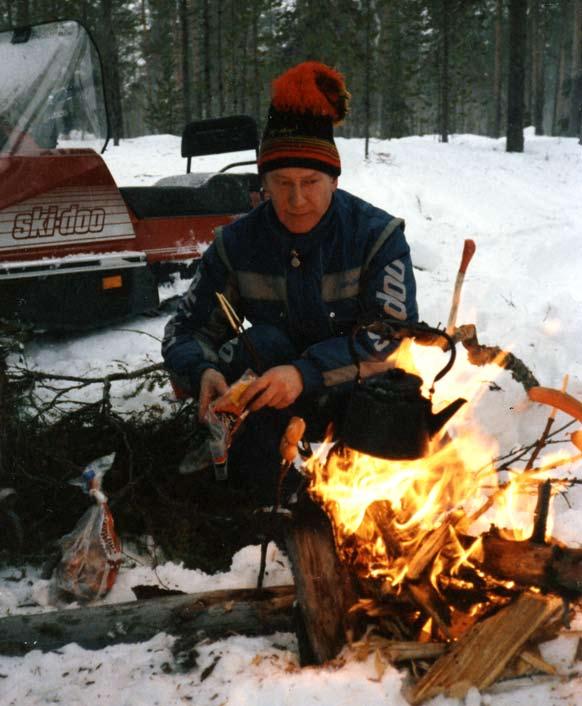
[263,167,337,233]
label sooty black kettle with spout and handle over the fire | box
[340,322,466,460]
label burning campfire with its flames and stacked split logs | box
[290,342,582,703]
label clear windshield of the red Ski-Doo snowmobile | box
[0,22,108,154]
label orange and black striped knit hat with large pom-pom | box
[258,61,350,177]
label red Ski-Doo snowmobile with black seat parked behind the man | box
[0,21,260,331]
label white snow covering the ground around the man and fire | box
[0,130,582,706]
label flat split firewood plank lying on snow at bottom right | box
[409,593,561,704]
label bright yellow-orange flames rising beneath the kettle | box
[306,342,559,604]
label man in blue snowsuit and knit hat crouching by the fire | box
[162,61,418,503]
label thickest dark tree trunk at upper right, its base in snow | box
[506,0,527,152]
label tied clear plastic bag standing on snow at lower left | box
[53,454,121,602]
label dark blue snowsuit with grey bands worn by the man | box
[162,189,418,500]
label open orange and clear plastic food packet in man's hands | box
[180,370,257,480]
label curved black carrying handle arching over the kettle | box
[348,312,457,393]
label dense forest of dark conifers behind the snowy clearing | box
[0,0,582,151]
